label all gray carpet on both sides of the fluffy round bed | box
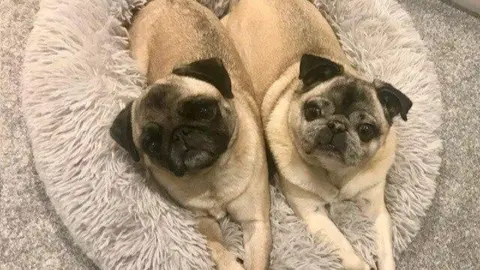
[0,0,480,269]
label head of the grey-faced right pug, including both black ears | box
[288,55,412,168]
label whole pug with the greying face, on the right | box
[222,0,412,269]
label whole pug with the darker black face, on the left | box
[110,0,271,270]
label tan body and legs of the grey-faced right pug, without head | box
[222,0,396,270]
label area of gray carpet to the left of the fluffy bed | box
[0,0,94,270]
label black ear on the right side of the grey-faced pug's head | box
[373,80,413,123]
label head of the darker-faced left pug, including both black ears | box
[111,59,236,177]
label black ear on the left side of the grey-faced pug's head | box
[298,54,343,86]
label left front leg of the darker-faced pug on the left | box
[197,216,244,270]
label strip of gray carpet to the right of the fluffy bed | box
[394,0,480,269]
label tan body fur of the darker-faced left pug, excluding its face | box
[129,0,271,270]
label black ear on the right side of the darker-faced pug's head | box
[172,57,233,98]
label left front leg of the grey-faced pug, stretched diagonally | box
[282,181,372,270]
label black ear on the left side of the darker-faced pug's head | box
[110,101,140,162]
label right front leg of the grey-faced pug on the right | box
[360,183,395,270]
